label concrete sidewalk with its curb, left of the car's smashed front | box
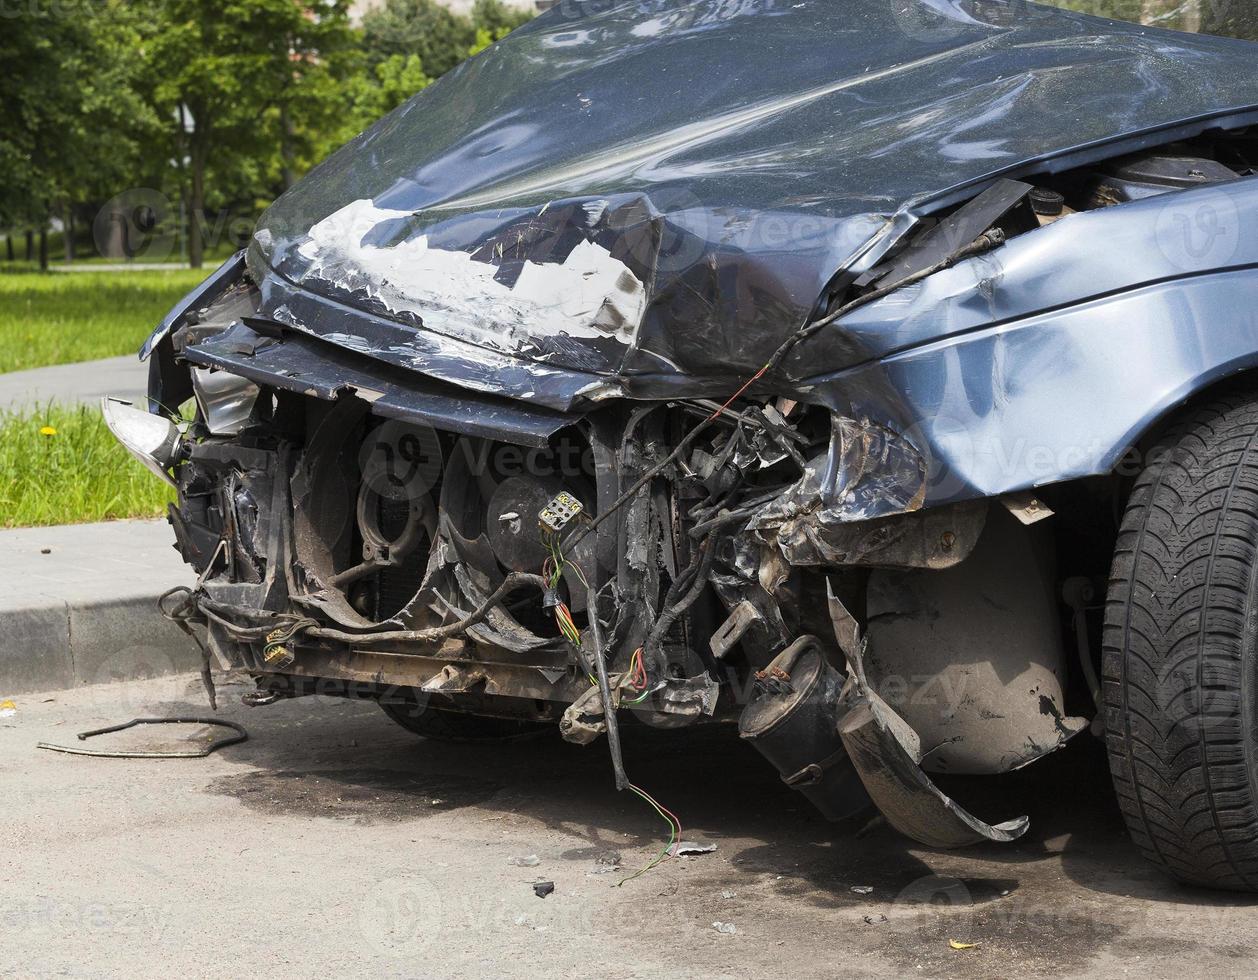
[0,521,200,697]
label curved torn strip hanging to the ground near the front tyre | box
[828,587,1030,848]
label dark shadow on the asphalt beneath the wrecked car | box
[185,687,1258,908]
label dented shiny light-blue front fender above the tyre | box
[800,176,1258,507]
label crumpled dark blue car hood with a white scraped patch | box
[250,0,1258,396]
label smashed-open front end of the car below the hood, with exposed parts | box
[118,262,1056,844]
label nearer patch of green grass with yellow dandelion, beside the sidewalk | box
[0,405,175,527]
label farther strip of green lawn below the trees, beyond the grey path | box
[0,268,213,372]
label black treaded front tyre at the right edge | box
[1103,394,1258,891]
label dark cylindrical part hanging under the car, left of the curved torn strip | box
[738,637,871,820]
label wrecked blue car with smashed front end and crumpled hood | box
[104,0,1258,889]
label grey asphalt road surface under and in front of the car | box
[0,674,1258,980]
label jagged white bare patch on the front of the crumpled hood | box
[298,200,647,350]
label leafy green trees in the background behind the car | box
[0,0,530,264]
